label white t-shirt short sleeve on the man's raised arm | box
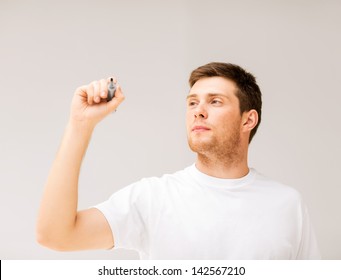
[94,179,149,252]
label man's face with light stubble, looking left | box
[186,77,242,157]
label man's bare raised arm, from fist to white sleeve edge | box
[37,79,124,251]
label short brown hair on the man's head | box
[189,62,262,143]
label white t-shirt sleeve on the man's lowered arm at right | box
[296,201,321,260]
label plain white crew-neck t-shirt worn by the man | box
[95,164,320,260]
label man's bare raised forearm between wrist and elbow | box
[37,122,93,246]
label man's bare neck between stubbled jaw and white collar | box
[195,154,249,179]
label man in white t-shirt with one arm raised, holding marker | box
[37,63,320,259]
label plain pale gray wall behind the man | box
[0,0,341,259]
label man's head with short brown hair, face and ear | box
[187,62,262,162]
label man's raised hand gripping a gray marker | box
[70,78,125,129]
